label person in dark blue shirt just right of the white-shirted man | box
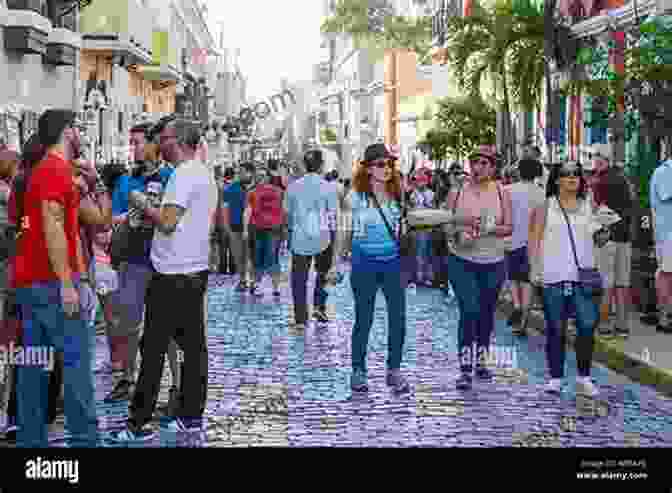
[221,162,256,293]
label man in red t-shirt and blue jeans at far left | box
[14,110,97,447]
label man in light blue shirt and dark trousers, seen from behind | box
[284,150,338,330]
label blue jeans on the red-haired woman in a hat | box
[350,257,406,372]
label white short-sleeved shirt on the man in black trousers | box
[151,160,217,274]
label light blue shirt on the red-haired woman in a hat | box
[350,191,401,261]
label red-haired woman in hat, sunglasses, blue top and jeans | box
[344,144,410,393]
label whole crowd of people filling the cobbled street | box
[0,110,672,447]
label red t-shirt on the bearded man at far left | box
[14,154,81,287]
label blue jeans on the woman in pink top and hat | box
[447,255,506,373]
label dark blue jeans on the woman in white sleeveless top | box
[543,283,600,378]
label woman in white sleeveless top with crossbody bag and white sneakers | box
[529,163,600,396]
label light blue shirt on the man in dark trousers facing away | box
[285,173,338,255]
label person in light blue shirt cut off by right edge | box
[649,157,672,334]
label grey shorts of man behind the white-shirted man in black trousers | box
[110,264,153,336]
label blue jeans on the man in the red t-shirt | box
[16,282,98,448]
